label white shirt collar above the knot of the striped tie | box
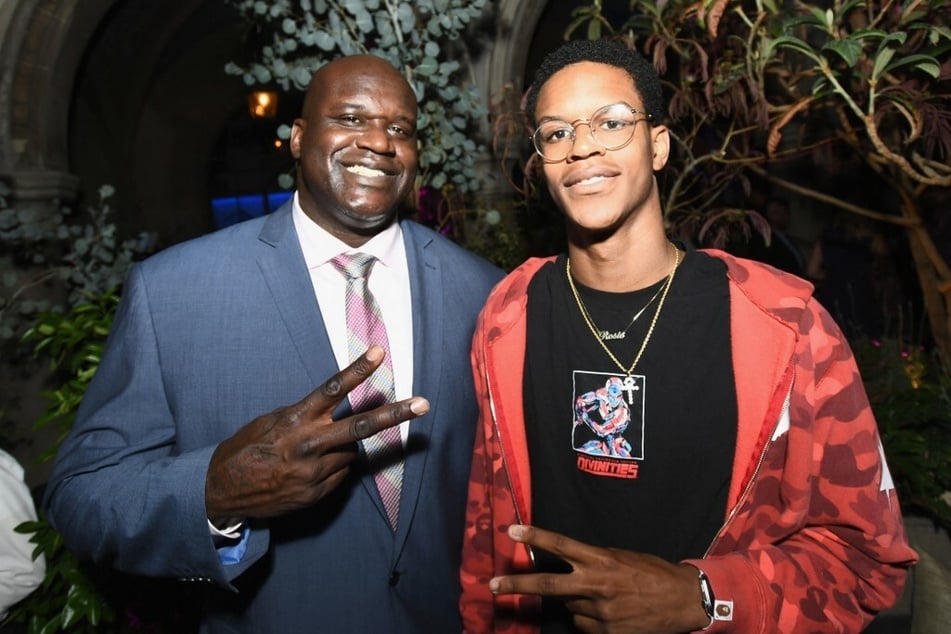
[291,192,403,270]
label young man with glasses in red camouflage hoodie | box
[461,41,916,633]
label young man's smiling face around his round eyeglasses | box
[535,62,669,235]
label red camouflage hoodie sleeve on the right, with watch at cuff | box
[687,300,917,634]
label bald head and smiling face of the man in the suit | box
[290,55,417,246]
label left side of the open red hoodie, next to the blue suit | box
[460,258,550,634]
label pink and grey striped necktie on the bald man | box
[330,253,403,530]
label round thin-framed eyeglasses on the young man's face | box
[532,102,654,163]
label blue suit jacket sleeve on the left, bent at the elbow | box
[44,267,268,585]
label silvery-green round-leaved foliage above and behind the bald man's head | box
[225,0,488,195]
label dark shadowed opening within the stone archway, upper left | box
[69,0,246,247]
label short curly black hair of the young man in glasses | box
[525,39,666,126]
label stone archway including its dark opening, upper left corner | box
[0,0,249,241]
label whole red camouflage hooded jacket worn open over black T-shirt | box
[460,250,917,634]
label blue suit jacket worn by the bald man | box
[46,205,501,634]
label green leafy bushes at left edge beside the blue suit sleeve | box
[0,185,155,634]
